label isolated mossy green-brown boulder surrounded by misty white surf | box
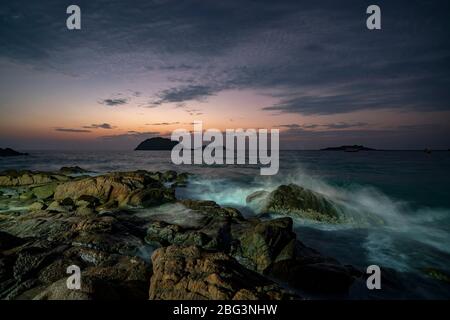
[247,184,344,223]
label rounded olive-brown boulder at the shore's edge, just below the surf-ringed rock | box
[233,218,296,273]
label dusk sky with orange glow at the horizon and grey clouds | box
[0,0,450,150]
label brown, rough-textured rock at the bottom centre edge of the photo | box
[149,246,293,300]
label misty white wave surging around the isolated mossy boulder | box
[184,166,450,271]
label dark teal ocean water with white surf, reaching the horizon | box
[0,151,450,299]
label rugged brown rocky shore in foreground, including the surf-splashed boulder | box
[0,167,362,300]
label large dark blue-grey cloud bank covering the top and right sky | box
[0,0,450,115]
